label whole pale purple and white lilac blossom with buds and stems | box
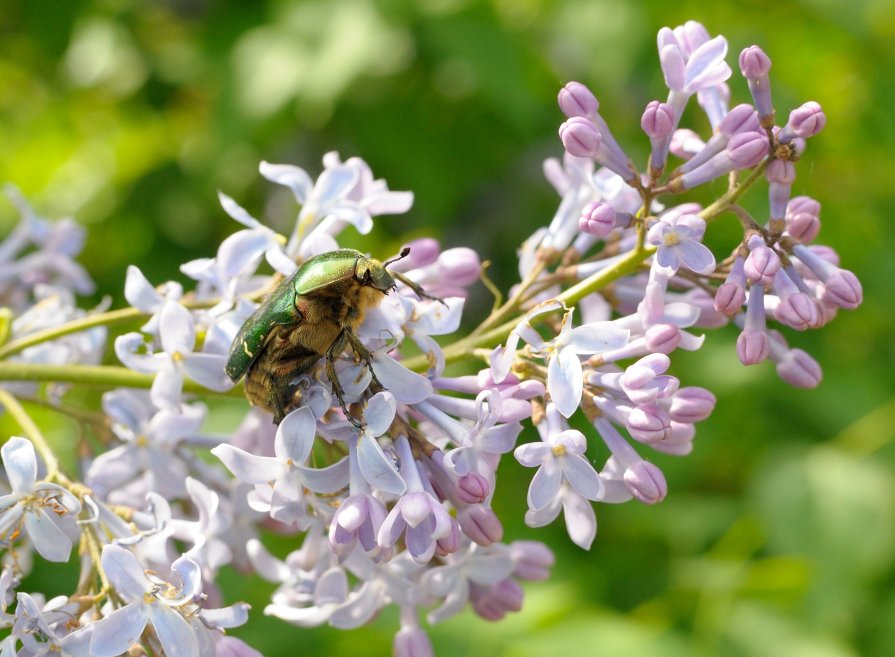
[0,22,861,657]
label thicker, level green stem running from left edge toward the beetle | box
[0,362,242,397]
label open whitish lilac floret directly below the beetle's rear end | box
[211,406,348,525]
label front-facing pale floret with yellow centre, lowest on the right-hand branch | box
[514,403,603,512]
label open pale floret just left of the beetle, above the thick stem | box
[115,301,233,408]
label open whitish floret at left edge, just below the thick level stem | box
[0,436,81,562]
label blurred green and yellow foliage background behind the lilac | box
[0,0,895,657]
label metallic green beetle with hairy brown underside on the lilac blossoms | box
[224,247,434,425]
